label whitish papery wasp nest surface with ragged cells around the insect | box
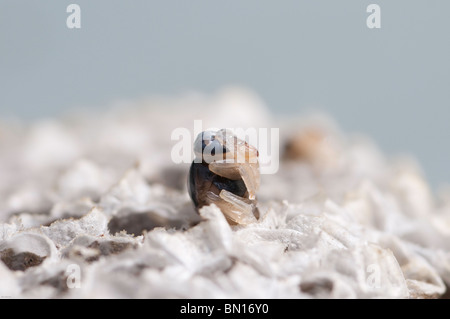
[0,89,450,298]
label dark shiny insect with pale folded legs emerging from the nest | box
[188,129,259,225]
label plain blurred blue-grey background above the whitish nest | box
[0,0,450,187]
